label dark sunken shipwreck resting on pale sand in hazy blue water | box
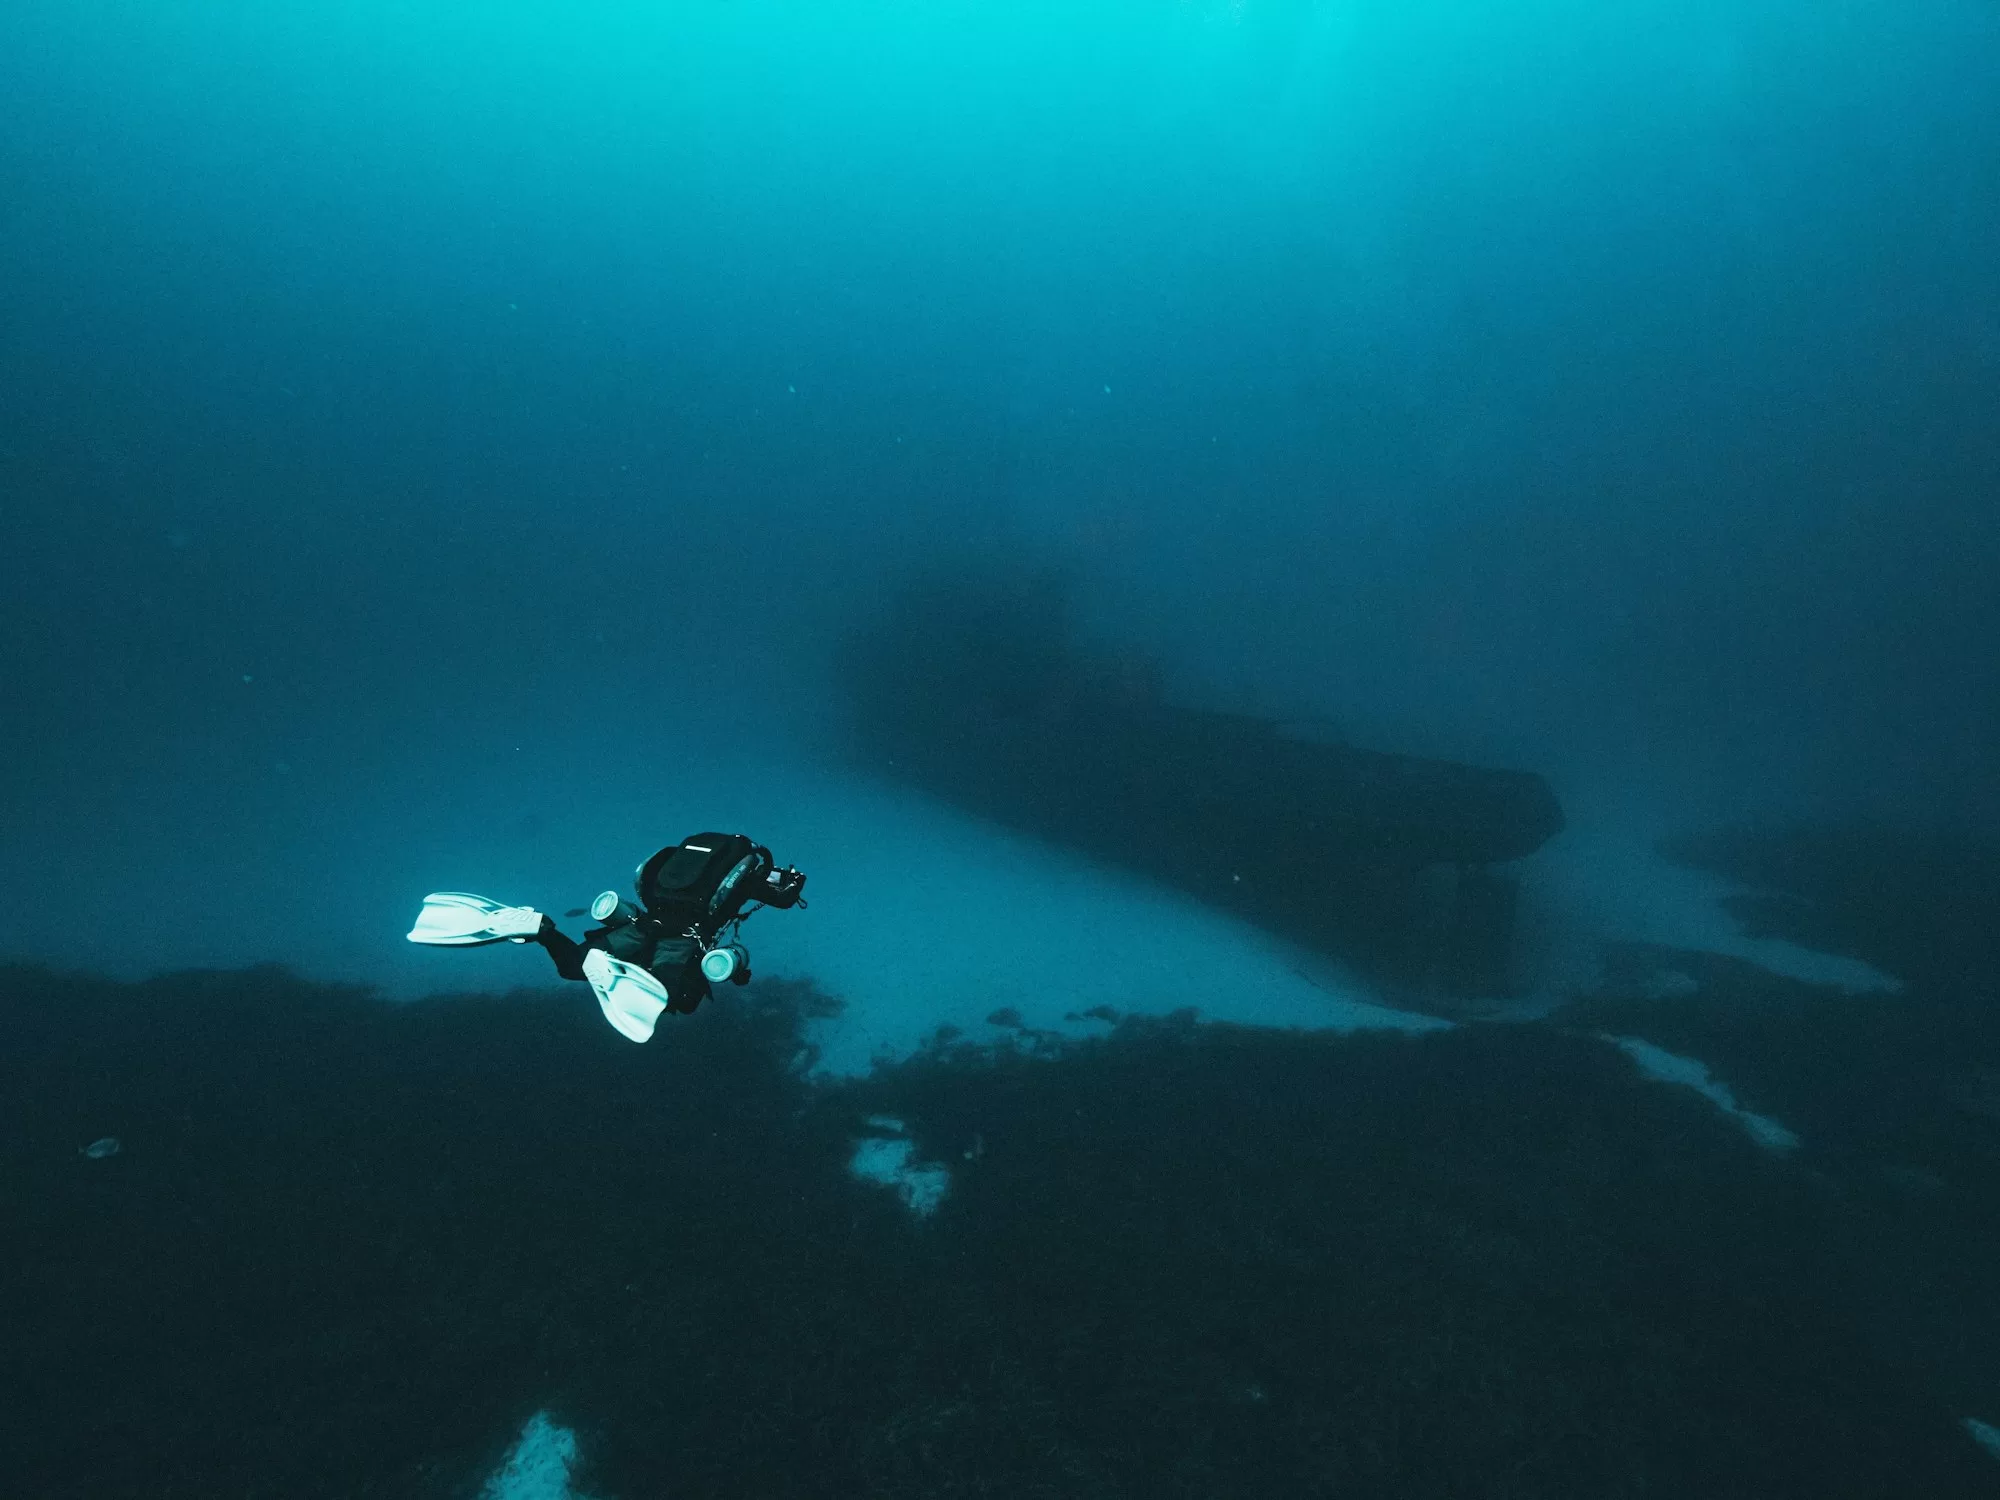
[844,578,1562,1004]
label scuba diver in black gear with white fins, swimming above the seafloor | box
[410,834,806,1042]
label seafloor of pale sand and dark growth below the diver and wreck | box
[0,774,2000,1500]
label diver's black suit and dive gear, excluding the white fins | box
[534,834,806,1014]
